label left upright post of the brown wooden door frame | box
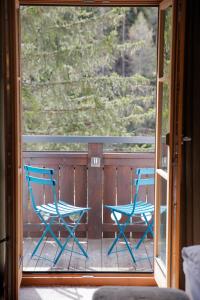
[2,0,22,299]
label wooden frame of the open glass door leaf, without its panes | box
[154,0,177,287]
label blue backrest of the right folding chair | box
[133,168,155,209]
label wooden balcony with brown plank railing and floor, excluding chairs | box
[23,136,154,272]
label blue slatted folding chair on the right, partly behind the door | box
[105,168,155,263]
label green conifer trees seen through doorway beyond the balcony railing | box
[21,6,157,151]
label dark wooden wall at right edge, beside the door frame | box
[181,0,200,287]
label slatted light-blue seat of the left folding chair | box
[37,200,89,216]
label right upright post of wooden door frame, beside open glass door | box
[155,0,186,288]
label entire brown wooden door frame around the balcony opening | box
[4,0,186,295]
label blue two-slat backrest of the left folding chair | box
[24,165,57,210]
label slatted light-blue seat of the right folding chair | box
[105,201,154,216]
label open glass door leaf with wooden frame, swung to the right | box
[155,1,173,286]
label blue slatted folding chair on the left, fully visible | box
[24,165,89,265]
